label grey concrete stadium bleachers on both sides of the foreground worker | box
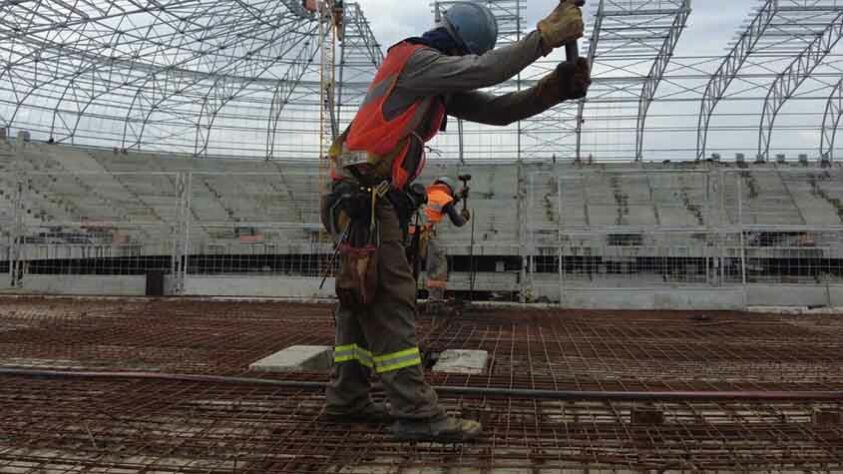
[0,141,843,255]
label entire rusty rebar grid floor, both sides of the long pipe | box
[0,298,843,474]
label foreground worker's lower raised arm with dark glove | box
[447,58,591,126]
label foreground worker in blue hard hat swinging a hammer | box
[322,0,591,442]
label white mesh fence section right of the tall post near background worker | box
[522,169,843,301]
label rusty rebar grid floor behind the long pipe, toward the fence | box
[0,297,843,391]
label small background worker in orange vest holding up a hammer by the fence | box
[421,177,471,312]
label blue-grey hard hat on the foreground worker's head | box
[441,2,498,55]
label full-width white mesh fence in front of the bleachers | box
[0,167,843,305]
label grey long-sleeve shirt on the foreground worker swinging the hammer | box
[384,32,550,125]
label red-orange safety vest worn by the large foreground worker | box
[345,42,445,189]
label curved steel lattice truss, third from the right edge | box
[697,0,779,160]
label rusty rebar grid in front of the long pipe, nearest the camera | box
[0,377,843,474]
